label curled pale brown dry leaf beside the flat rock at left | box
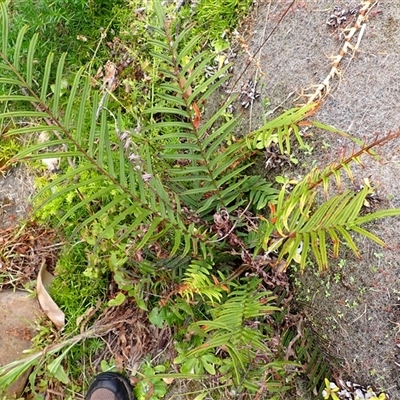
[37,260,65,329]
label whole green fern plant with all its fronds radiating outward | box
[0,1,400,391]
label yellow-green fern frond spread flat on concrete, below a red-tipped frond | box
[265,186,400,270]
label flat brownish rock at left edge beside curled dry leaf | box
[0,290,40,398]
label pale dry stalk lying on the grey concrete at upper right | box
[306,1,375,104]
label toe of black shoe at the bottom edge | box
[85,372,135,400]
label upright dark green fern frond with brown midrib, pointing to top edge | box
[146,5,258,216]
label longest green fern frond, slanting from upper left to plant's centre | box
[0,3,197,252]
